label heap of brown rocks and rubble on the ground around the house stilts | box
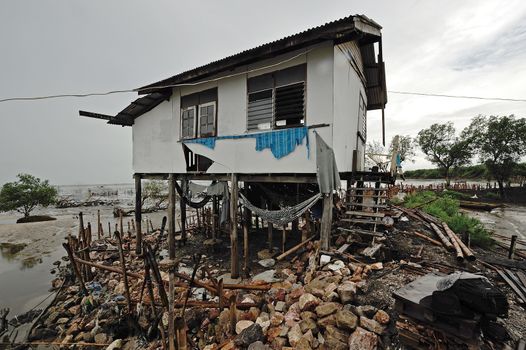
[7,189,524,350]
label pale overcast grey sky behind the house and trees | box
[0,0,526,184]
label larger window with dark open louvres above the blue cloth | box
[247,64,306,131]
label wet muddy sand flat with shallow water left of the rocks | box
[0,206,166,318]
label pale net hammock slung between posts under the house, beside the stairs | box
[239,193,322,226]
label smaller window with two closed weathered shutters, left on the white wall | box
[181,88,217,139]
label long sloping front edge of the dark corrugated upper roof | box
[137,15,382,95]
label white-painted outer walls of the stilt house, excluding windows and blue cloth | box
[132,42,370,174]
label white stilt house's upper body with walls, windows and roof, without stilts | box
[81,15,387,179]
